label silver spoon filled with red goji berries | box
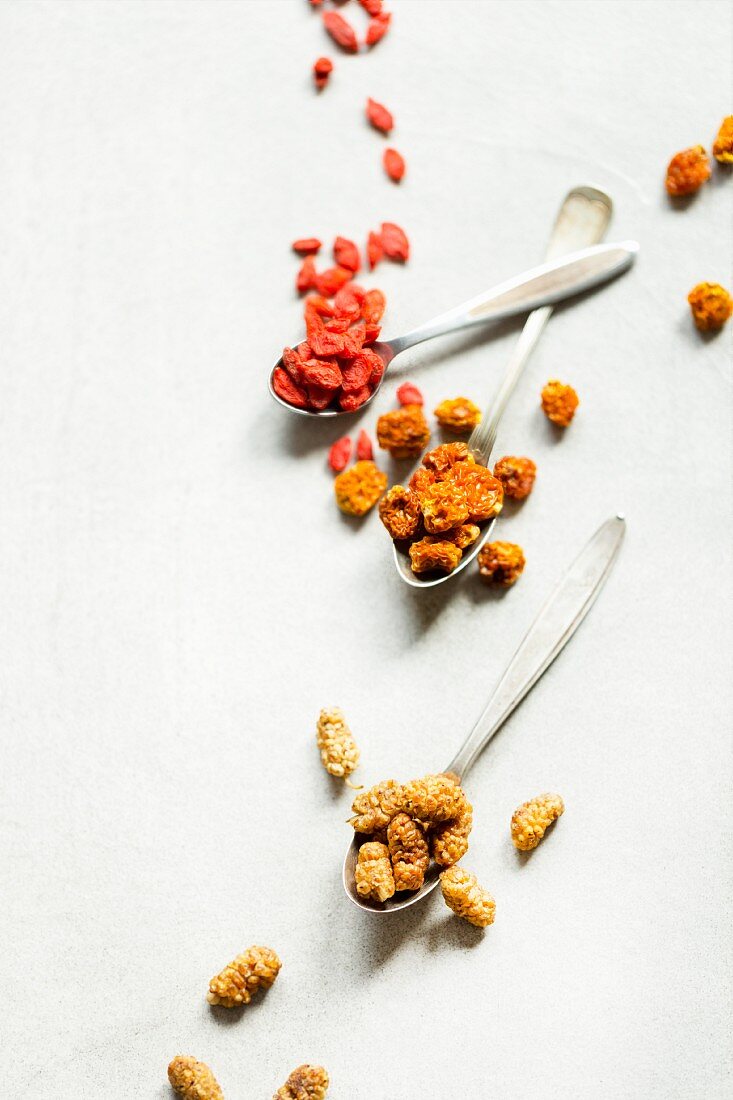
[269,241,638,417]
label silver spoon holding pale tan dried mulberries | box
[343,516,626,913]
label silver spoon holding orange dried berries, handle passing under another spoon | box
[393,186,613,589]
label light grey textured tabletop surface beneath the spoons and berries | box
[0,0,733,1100]
